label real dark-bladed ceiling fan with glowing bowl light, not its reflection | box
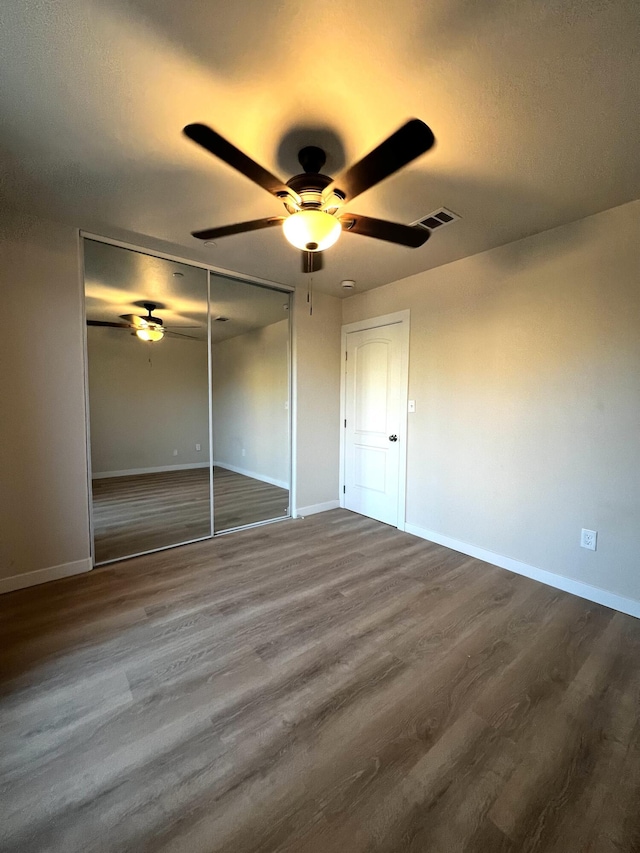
[183,118,435,273]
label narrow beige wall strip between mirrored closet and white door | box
[294,288,342,515]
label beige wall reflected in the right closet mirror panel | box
[211,319,290,489]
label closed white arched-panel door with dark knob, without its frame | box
[344,323,402,526]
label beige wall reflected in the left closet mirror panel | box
[87,326,209,477]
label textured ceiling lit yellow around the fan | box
[0,0,640,295]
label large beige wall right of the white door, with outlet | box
[343,201,640,604]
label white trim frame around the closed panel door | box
[340,308,411,530]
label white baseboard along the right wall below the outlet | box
[405,524,640,619]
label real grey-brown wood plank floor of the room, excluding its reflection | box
[0,510,640,853]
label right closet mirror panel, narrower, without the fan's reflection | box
[210,273,291,533]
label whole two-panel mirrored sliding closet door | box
[83,238,291,565]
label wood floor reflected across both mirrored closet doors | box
[93,468,289,563]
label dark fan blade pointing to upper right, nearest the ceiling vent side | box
[323,118,435,201]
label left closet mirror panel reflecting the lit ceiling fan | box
[84,239,212,564]
